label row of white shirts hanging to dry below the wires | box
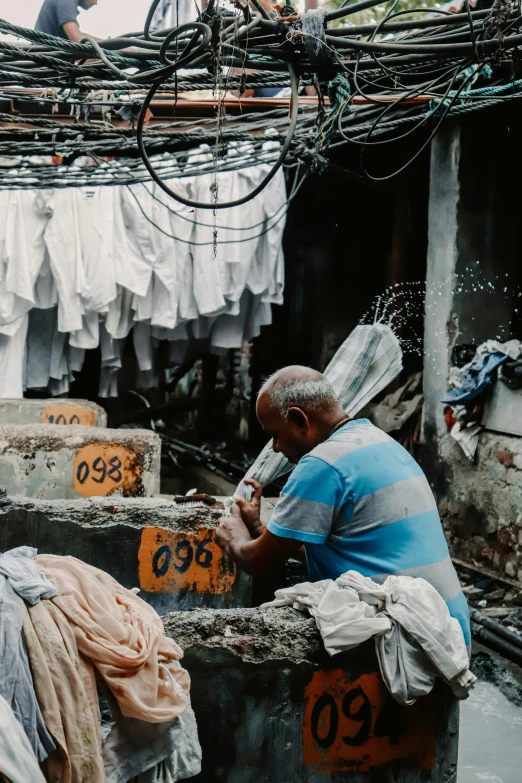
[0,142,287,397]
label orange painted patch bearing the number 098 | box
[73,443,141,497]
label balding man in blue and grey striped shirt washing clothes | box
[216,367,470,644]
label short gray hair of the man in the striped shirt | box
[258,370,338,419]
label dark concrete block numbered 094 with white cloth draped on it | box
[163,608,458,783]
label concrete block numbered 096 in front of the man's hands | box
[0,496,252,614]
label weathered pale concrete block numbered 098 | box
[0,424,161,499]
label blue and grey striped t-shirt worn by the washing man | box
[268,419,471,645]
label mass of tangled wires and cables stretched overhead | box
[0,0,522,199]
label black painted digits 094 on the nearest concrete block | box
[310,686,406,750]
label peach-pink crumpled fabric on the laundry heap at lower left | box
[36,555,190,723]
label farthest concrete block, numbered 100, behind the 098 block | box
[0,399,107,427]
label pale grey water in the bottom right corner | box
[457,682,522,783]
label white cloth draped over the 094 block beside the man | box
[264,571,476,704]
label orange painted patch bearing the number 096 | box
[138,527,236,595]
